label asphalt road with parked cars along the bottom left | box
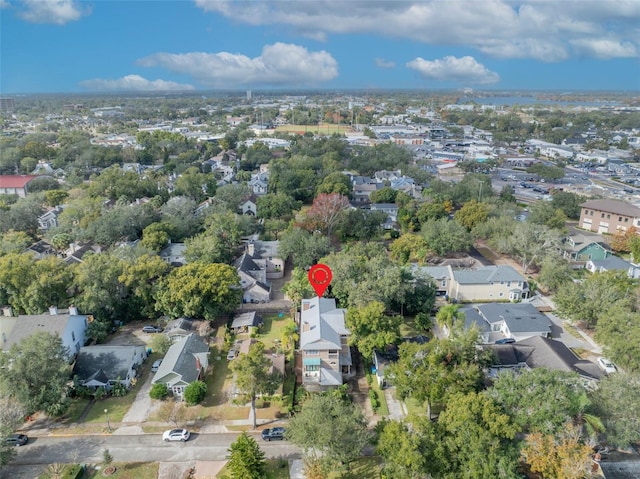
[7,433,300,466]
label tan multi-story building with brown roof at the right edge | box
[578,199,640,234]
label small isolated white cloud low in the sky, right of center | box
[407,56,500,85]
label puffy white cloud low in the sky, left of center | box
[138,43,338,87]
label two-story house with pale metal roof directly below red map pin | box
[300,296,353,390]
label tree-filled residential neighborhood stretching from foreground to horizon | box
[0,86,640,479]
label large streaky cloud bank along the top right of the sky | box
[195,0,640,62]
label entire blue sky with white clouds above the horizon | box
[0,0,640,94]
